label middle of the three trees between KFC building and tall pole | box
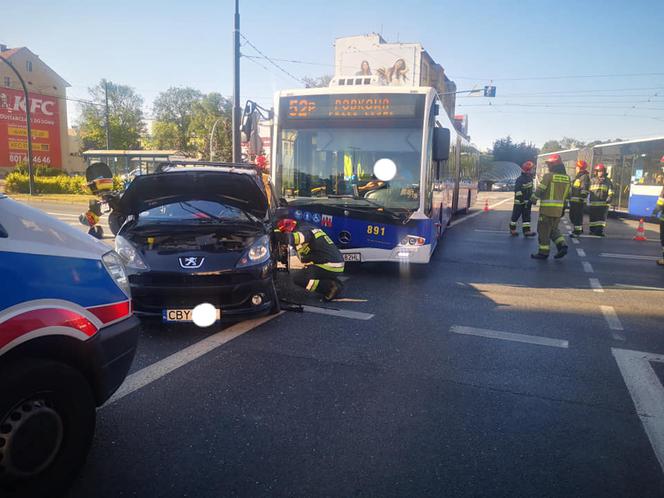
[152,87,203,152]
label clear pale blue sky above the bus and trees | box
[0,0,664,148]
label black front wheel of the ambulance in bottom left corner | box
[0,359,96,497]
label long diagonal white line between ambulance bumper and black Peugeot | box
[104,315,279,407]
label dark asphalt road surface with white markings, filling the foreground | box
[18,193,664,498]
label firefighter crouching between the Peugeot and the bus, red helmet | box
[277,218,344,301]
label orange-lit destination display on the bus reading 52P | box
[280,94,419,121]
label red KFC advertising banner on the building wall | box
[0,88,62,168]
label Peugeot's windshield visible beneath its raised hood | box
[139,200,255,223]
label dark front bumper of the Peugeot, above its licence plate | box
[129,263,277,319]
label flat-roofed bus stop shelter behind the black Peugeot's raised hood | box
[82,150,184,176]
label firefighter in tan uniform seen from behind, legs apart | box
[531,154,570,259]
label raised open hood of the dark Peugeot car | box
[119,170,268,219]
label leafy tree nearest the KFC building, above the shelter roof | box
[79,80,145,150]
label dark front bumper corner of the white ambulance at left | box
[84,316,141,405]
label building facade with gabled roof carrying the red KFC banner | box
[0,45,71,175]
